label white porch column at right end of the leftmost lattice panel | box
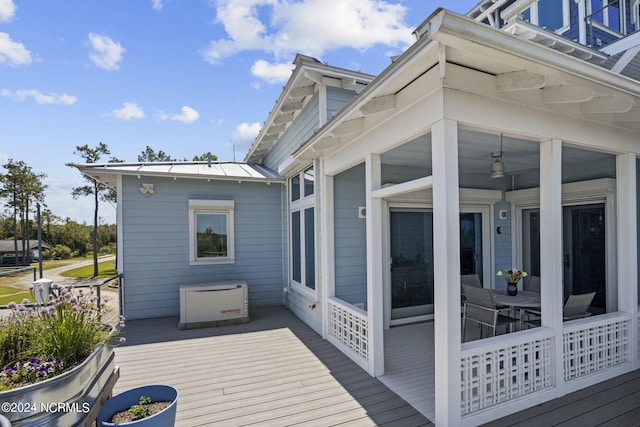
[365,154,385,377]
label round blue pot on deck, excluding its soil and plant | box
[96,385,178,427]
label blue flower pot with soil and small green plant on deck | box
[96,384,178,427]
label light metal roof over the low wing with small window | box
[71,162,284,183]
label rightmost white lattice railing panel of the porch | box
[563,313,631,381]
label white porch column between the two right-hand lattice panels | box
[540,139,564,395]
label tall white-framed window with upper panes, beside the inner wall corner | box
[289,167,316,290]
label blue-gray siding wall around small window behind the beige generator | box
[120,176,284,319]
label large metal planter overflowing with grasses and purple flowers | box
[0,284,124,426]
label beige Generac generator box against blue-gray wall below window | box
[178,280,249,329]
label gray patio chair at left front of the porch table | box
[462,285,518,341]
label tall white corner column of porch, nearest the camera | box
[431,119,461,426]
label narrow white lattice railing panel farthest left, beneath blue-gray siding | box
[328,297,369,365]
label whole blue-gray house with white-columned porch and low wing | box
[76,0,640,426]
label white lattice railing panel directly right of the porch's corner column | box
[461,331,553,416]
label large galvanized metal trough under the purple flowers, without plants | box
[0,344,118,427]
